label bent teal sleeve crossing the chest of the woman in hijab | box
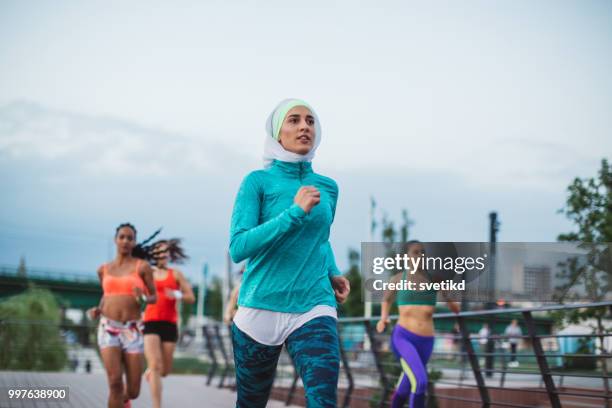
[230,174,306,263]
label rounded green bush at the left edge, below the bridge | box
[0,287,67,371]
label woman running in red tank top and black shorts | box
[144,239,195,408]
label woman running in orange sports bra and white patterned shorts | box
[89,224,157,408]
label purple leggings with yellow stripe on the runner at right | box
[391,325,434,408]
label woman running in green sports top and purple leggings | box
[376,241,460,408]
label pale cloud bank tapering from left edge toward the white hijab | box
[0,102,253,179]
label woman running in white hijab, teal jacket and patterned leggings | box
[230,99,350,408]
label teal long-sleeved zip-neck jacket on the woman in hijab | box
[230,160,341,313]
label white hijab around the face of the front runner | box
[263,99,321,168]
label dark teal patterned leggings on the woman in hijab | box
[232,316,340,408]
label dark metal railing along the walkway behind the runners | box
[203,302,612,408]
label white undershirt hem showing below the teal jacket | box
[234,305,338,346]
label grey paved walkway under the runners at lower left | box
[0,371,296,408]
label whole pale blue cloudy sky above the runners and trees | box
[0,1,612,278]
